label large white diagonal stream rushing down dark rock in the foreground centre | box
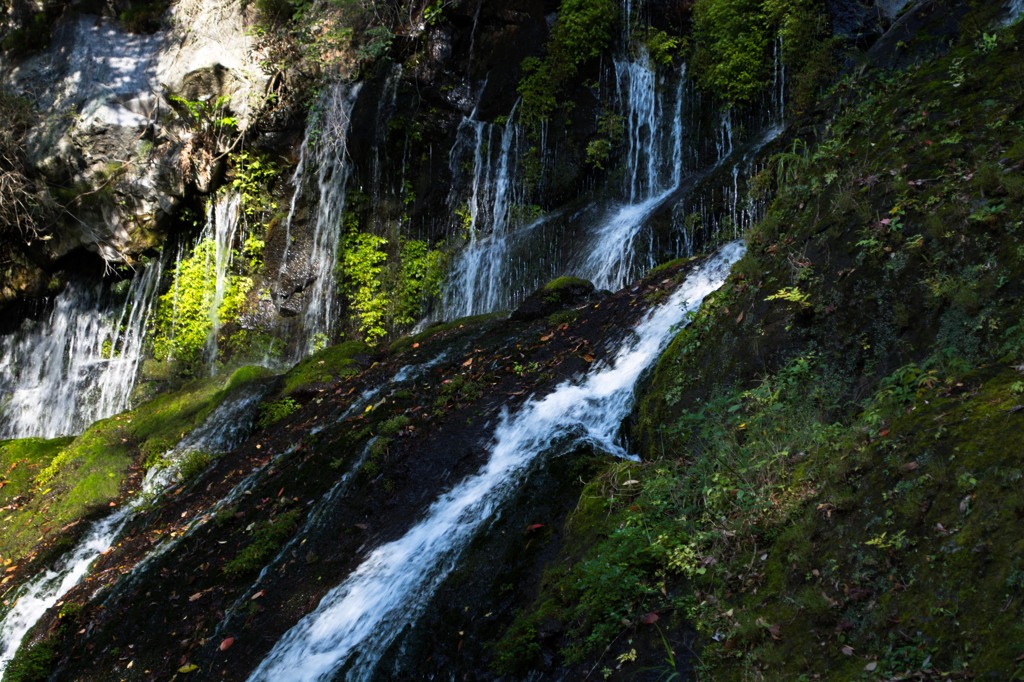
[249,243,743,682]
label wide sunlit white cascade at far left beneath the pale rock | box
[0,259,162,438]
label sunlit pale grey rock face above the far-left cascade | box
[0,0,267,262]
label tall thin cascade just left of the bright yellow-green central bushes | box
[297,83,361,356]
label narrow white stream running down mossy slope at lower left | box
[0,378,265,677]
